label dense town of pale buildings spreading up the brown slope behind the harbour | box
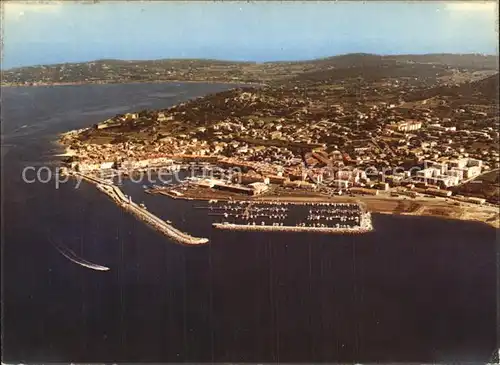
[62,57,500,205]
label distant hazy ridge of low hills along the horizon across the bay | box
[2,53,498,85]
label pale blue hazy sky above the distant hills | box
[2,1,498,69]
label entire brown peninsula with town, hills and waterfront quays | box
[52,54,500,236]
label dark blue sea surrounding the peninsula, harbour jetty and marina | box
[1,83,500,363]
